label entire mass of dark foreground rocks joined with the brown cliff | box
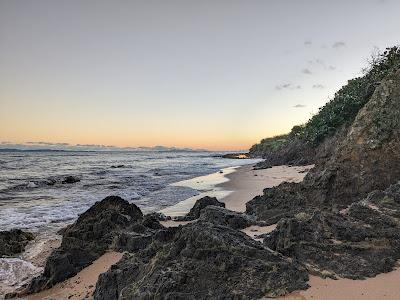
[5,49,400,300]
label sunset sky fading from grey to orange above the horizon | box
[0,0,400,150]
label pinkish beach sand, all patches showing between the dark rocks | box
[10,164,400,300]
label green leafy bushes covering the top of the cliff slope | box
[250,46,400,155]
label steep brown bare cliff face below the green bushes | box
[246,70,400,223]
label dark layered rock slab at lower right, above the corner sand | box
[264,184,400,279]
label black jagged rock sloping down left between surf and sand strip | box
[28,196,145,292]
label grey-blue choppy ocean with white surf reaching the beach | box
[0,151,256,233]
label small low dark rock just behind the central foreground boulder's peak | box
[199,205,256,229]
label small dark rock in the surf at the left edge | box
[0,229,35,257]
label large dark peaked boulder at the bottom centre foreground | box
[94,220,308,300]
